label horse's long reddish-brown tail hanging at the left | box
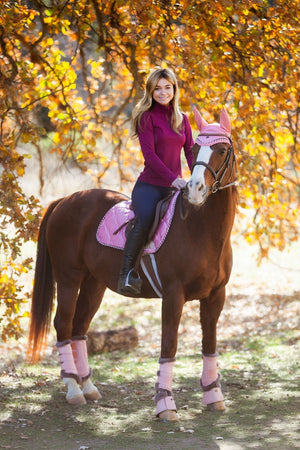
[27,199,61,362]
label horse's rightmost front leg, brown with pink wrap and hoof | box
[200,287,225,411]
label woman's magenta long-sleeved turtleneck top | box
[138,102,194,187]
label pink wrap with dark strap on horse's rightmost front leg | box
[201,355,224,405]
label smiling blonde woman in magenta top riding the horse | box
[118,68,194,295]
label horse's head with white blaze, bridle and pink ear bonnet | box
[187,108,235,205]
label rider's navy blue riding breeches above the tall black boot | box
[132,180,172,231]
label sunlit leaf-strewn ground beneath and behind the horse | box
[0,241,300,450]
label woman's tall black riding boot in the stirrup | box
[118,219,148,295]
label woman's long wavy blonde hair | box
[132,68,183,136]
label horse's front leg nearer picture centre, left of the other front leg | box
[155,285,185,421]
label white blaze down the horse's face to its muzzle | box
[188,146,212,205]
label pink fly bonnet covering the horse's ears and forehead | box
[194,108,231,147]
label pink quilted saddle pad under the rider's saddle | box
[96,191,179,254]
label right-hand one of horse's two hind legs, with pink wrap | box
[71,275,105,400]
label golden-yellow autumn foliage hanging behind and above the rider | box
[0,0,300,338]
